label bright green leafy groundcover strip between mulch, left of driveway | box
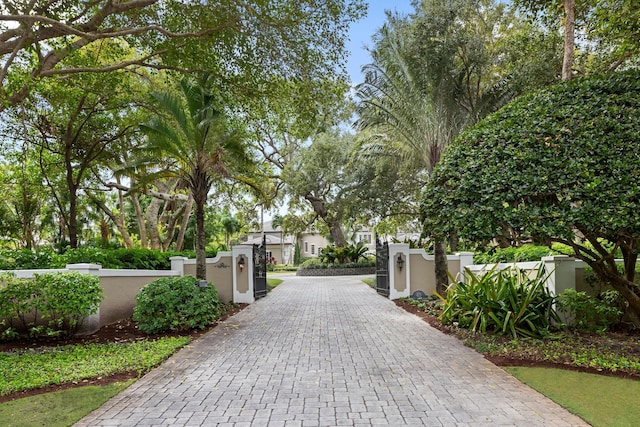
[0,337,189,395]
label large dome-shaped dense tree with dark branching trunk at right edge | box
[422,70,640,325]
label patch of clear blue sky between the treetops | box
[346,0,413,85]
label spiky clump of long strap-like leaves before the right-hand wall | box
[440,266,559,338]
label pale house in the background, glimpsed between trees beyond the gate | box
[242,221,376,264]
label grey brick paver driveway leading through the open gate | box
[77,276,587,426]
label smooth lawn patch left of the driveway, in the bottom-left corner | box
[0,380,133,427]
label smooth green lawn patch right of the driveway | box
[504,367,640,427]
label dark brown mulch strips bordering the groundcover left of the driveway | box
[0,304,247,403]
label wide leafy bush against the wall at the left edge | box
[0,272,103,339]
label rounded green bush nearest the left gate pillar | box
[133,276,220,334]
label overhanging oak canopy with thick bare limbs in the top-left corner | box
[0,0,365,116]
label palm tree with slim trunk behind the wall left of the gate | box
[136,74,254,280]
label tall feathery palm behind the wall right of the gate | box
[356,20,463,292]
